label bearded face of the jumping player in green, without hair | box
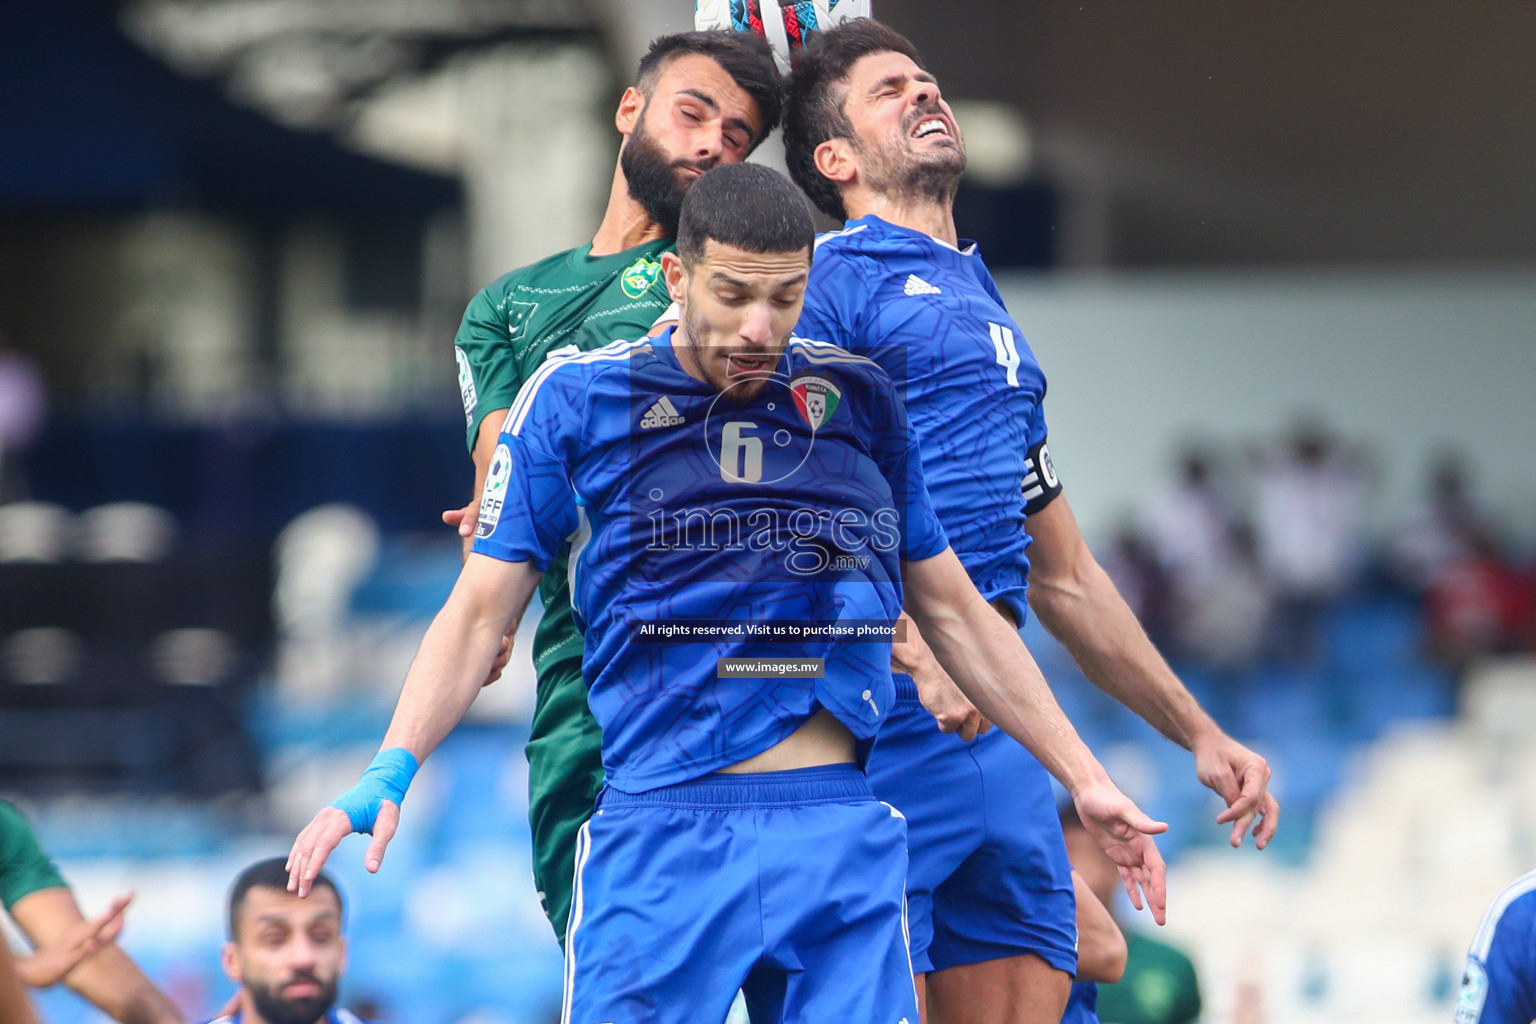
[614,54,762,235]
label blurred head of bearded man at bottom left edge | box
[221,857,347,1024]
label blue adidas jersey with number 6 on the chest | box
[473,332,948,792]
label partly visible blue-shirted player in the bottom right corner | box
[1455,870,1536,1024]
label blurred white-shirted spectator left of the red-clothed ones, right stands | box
[1253,419,1367,656]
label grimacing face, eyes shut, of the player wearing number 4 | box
[823,51,965,195]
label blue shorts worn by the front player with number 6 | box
[561,765,917,1024]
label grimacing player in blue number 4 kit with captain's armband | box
[783,20,1278,1024]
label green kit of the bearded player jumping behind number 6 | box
[453,239,673,944]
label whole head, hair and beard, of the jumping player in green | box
[614,32,783,235]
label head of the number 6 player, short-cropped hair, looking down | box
[662,164,816,401]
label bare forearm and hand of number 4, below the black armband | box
[1026,494,1279,849]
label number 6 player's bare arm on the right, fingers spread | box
[906,548,1167,924]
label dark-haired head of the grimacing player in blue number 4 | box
[783,18,965,220]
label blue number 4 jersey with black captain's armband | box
[796,215,1060,622]
